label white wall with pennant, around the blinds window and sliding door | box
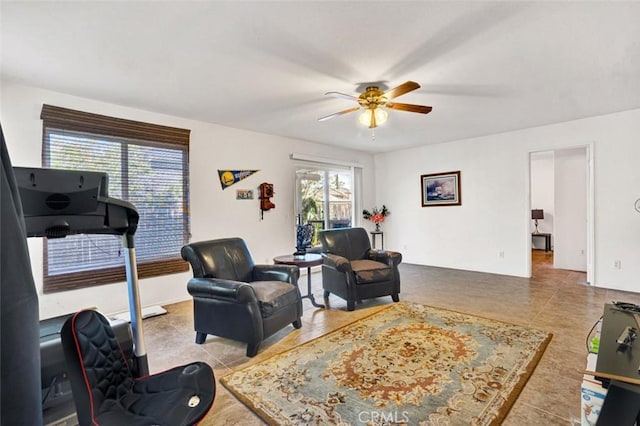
[0,81,373,318]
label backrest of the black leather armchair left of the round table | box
[180,238,254,282]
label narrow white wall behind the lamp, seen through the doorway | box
[529,151,555,249]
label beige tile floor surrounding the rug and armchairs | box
[144,250,640,426]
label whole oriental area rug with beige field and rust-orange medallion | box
[221,302,551,425]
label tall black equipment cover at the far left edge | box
[0,126,42,426]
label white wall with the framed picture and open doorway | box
[375,109,640,291]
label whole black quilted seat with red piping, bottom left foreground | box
[60,310,215,426]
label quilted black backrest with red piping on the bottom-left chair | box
[60,310,134,424]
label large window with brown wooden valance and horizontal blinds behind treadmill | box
[41,105,190,293]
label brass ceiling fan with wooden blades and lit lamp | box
[318,81,432,129]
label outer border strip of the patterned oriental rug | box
[220,301,553,426]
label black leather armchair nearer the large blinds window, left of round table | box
[181,238,302,357]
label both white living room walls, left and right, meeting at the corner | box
[5,81,640,312]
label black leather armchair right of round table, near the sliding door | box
[318,228,402,311]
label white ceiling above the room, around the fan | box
[0,0,640,152]
